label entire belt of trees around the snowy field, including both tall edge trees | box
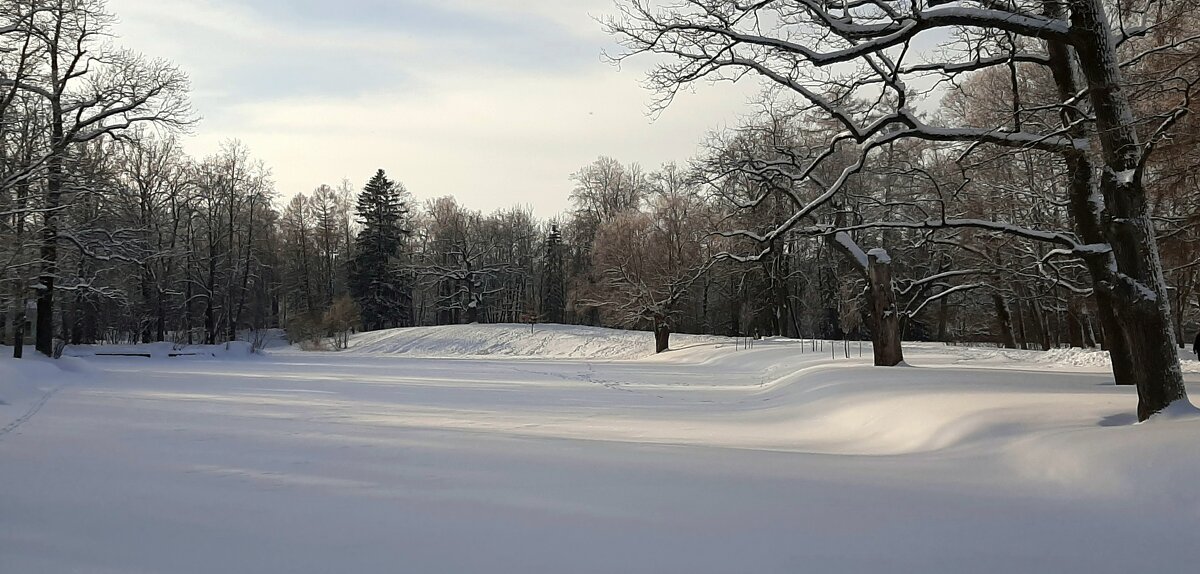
[0,0,1200,418]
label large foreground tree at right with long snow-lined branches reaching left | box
[607,0,1194,419]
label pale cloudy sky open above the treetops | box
[109,0,754,217]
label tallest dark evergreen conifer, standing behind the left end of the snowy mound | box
[349,169,413,330]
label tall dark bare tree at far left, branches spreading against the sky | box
[0,0,190,354]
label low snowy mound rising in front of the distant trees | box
[349,323,728,359]
